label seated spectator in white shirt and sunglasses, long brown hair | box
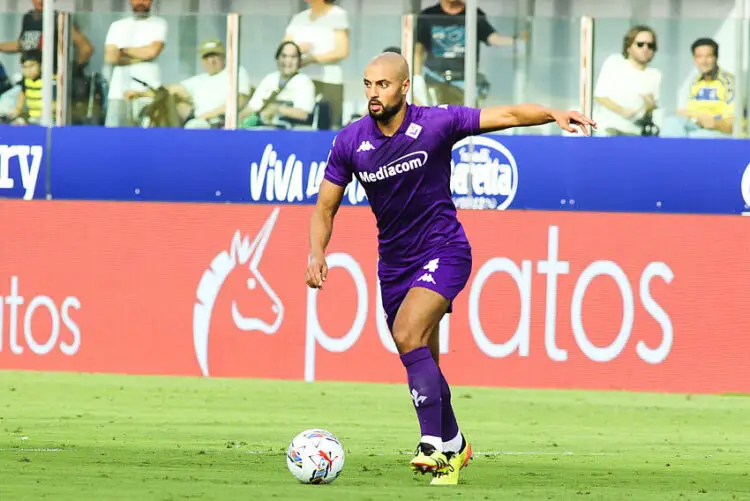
[593,26,661,136]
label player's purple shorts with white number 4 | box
[378,245,471,331]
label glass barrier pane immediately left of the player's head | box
[250,6,402,130]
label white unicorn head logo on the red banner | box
[193,207,284,376]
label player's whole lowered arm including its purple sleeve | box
[305,135,352,289]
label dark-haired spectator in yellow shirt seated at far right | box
[661,38,734,138]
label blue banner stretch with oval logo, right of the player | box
[452,136,750,214]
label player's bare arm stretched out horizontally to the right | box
[479,104,596,136]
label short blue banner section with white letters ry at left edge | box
[0,125,47,200]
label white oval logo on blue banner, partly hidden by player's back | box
[451,136,518,210]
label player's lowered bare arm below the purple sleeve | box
[305,179,344,289]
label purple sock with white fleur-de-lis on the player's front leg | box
[401,346,443,451]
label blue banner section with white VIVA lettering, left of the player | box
[52,127,352,203]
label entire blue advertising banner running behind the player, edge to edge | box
[5,127,750,214]
